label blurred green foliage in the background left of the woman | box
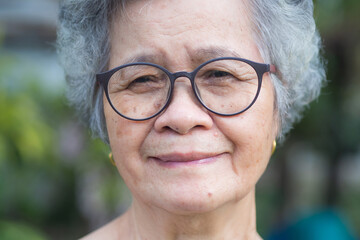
[0,49,122,239]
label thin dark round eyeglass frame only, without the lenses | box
[96,57,276,121]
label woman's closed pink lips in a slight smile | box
[150,152,222,167]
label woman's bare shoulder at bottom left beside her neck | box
[80,213,129,240]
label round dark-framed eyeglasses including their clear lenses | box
[96,57,275,121]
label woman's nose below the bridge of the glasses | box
[154,77,213,135]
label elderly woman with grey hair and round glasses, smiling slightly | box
[58,0,325,240]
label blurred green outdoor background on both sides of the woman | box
[0,0,360,240]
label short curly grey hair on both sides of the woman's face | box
[57,0,325,142]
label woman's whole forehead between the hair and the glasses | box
[110,0,256,68]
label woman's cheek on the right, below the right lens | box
[214,84,277,176]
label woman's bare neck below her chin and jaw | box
[127,190,261,240]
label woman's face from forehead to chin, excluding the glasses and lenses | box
[104,0,277,213]
